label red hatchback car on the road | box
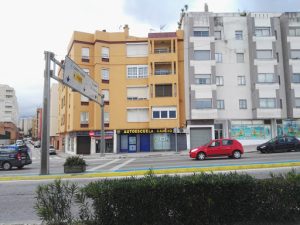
[190,139,244,160]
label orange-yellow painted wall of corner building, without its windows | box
[58,26,185,154]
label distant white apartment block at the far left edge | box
[0,84,19,126]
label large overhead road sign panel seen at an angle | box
[63,56,99,101]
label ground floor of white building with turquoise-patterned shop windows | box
[187,119,300,148]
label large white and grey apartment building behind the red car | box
[183,11,300,148]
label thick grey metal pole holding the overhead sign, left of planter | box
[41,51,53,175]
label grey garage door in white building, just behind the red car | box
[190,127,211,148]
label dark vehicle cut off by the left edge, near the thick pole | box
[0,144,32,170]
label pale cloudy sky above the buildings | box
[0,0,300,117]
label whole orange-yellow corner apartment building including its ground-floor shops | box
[58,25,186,154]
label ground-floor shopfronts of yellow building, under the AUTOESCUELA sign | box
[59,128,187,155]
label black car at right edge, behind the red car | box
[256,136,300,153]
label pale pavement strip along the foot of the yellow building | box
[57,145,256,159]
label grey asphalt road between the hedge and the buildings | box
[0,144,300,224]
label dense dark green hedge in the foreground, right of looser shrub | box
[83,173,300,225]
